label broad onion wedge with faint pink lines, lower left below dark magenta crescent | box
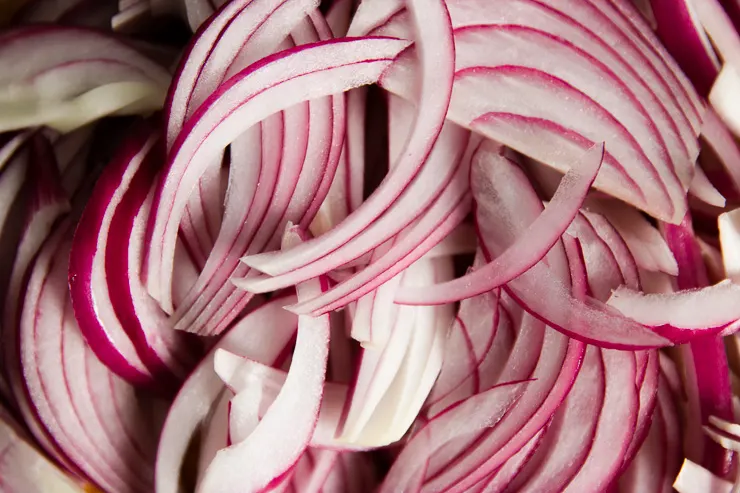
[20,225,159,492]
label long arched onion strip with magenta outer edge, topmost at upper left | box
[148,38,407,312]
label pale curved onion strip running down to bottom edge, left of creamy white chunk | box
[198,227,330,493]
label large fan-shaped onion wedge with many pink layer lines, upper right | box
[373,0,697,222]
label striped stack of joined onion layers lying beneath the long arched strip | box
[175,14,345,333]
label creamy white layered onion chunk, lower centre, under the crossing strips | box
[339,259,452,446]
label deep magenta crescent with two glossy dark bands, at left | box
[69,123,193,386]
